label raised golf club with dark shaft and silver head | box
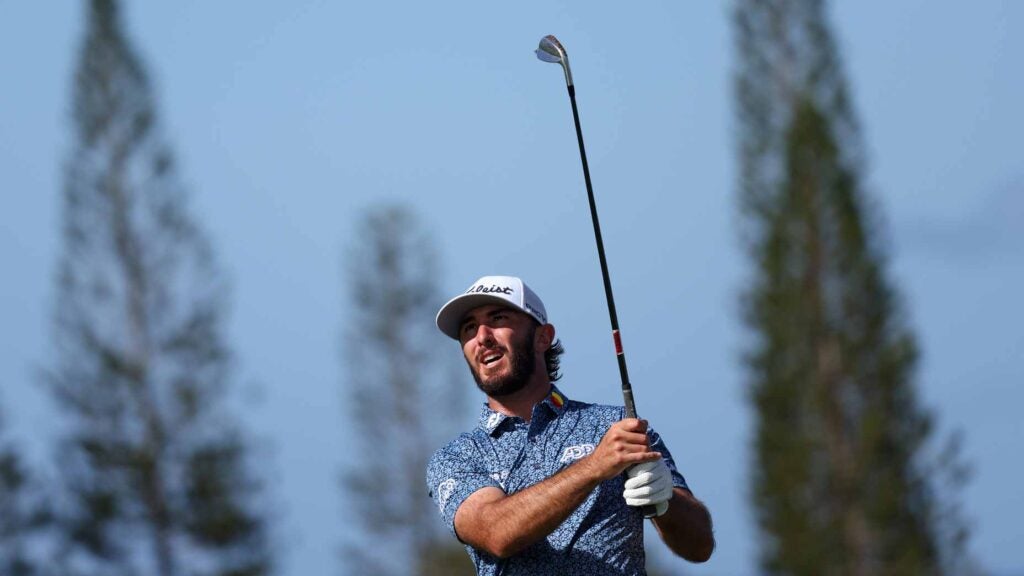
[537,35,655,518]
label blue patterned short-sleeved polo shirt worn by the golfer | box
[427,386,686,576]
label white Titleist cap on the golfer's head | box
[437,276,548,340]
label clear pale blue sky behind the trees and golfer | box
[0,0,1024,576]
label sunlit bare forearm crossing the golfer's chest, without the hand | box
[467,458,601,558]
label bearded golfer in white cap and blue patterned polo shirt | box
[427,276,715,575]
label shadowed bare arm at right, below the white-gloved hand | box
[653,487,715,562]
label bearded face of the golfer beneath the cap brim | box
[459,305,537,398]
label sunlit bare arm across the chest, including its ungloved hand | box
[455,418,659,558]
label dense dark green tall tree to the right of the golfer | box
[734,0,967,576]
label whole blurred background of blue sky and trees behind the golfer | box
[0,0,1024,576]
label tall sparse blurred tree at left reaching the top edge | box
[47,0,271,576]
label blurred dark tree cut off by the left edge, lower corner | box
[0,407,50,576]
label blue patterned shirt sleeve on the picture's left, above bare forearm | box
[427,436,501,537]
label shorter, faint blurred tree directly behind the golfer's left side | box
[342,205,473,576]
